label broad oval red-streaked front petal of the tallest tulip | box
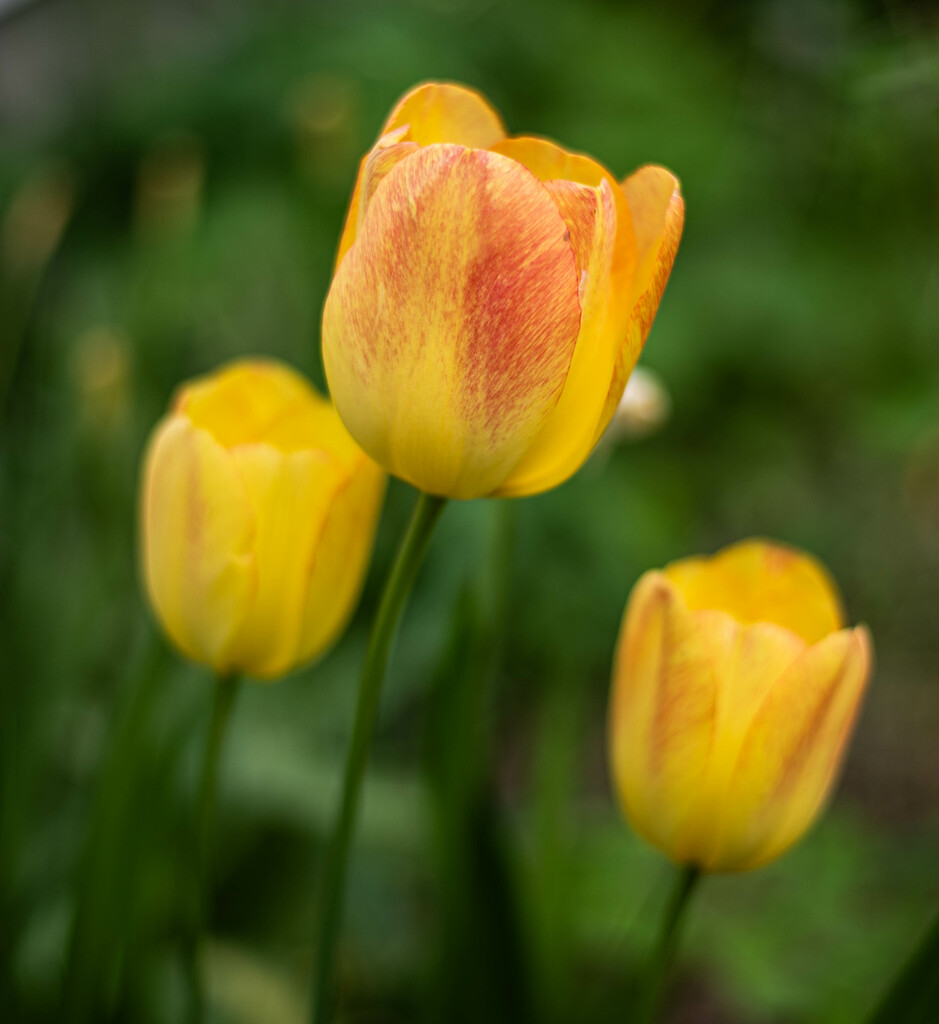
[323,145,581,498]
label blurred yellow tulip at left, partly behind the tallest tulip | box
[140,360,385,678]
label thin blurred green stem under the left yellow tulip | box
[188,674,239,1020]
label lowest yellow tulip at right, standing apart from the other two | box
[609,541,870,871]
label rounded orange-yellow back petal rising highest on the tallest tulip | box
[336,82,505,267]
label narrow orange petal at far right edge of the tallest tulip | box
[596,166,685,440]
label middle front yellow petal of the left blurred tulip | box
[221,444,349,678]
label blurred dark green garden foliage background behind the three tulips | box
[0,0,939,1024]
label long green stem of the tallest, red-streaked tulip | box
[310,494,446,1024]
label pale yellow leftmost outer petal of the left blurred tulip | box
[141,415,257,671]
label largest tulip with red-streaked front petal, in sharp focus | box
[323,84,684,498]
